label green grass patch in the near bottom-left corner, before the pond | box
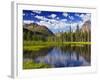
[23,61,50,69]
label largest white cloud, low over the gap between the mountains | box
[38,19,70,32]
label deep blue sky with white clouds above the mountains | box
[23,10,91,33]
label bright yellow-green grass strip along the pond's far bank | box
[23,41,91,51]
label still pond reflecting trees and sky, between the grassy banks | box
[23,45,91,68]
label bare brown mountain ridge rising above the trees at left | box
[23,23,54,36]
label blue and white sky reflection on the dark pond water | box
[35,48,89,67]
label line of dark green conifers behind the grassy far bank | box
[23,25,91,42]
